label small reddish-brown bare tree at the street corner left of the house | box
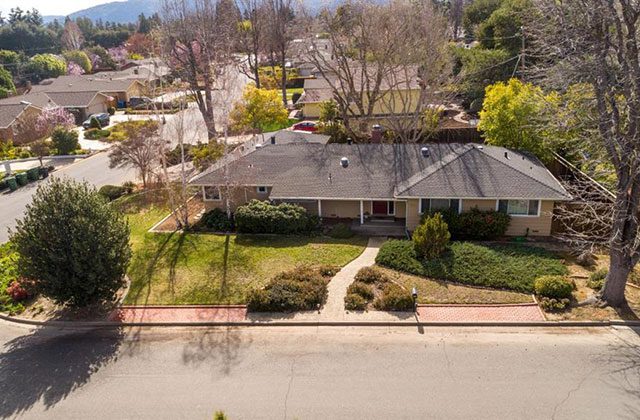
[109,120,163,189]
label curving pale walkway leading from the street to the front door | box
[320,237,387,321]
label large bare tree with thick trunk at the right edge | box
[527,0,640,306]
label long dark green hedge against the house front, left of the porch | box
[235,200,319,234]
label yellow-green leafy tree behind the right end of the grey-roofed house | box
[478,79,557,161]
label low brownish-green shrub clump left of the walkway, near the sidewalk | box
[247,267,328,312]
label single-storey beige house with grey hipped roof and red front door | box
[190,143,571,236]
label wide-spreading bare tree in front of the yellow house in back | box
[311,0,451,142]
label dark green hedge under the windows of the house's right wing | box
[422,208,511,241]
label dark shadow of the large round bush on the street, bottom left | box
[0,328,123,418]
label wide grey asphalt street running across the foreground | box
[0,324,640,420]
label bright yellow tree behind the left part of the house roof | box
[231,85,288,133]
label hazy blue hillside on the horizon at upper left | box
[44,0,162,23]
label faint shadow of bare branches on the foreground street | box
[182,327,252,375]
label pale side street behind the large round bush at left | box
[0,152,136,243]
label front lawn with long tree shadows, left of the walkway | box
[119,195,366,304]
